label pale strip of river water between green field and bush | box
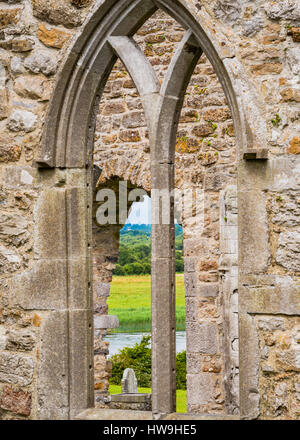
[104,331,186,356]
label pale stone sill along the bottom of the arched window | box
[75,408,240,420]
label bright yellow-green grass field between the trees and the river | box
[107,274,185,333]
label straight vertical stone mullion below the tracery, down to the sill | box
[151,158,176,415]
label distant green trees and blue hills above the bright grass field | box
[114,224,184,275]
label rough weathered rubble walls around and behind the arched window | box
[0,0,300,419]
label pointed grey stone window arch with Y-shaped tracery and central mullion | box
[37,0,265,418]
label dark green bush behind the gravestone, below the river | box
[109,336,186,390]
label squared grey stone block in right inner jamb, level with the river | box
[186,322,218,354]
